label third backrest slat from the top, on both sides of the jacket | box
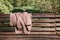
[0,23,60,26]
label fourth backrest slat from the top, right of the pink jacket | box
[31,27,60,32]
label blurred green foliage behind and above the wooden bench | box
[0,0,60,14]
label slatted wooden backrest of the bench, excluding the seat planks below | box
[0,13,60,34]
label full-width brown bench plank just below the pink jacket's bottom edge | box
[0,34,60,39]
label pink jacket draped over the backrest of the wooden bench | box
[10,12,32,34]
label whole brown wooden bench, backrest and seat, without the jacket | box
[0,13,60,40]
